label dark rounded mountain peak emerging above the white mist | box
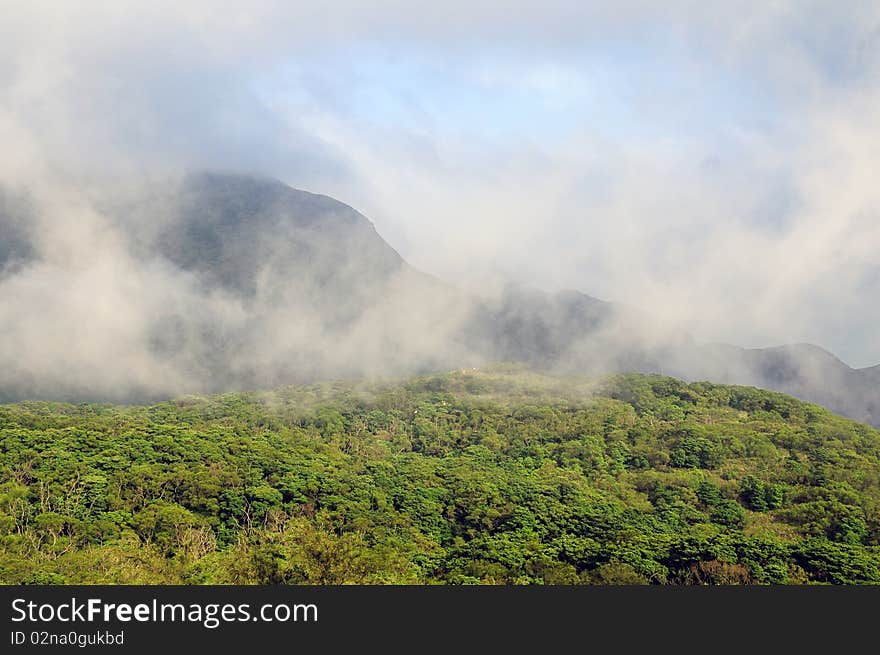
[148,172,404,296]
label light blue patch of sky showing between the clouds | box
[255,41,782,158]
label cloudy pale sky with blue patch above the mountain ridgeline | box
[0,0,880,366]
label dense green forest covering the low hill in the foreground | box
[0,365,880,585]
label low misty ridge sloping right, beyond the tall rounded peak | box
[474,292,880,426]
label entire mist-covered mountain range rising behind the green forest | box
[0,173,880,425]
